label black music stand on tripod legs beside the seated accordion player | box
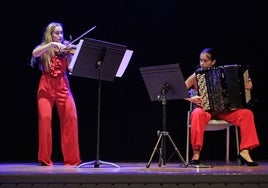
[140,64,189,168]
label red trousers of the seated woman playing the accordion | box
[191,108,260,150]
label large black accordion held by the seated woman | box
[195,64,251,112]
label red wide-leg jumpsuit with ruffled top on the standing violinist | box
[37,56,81,166]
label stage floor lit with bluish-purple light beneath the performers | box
[0,161,268,188]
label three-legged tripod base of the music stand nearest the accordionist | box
[146,131,188,168]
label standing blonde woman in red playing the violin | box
[32,22,81,166]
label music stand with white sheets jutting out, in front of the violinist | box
[68,38,133,168]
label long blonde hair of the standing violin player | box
[41,22,64,71]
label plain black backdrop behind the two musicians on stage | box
[0,0,268,162]
